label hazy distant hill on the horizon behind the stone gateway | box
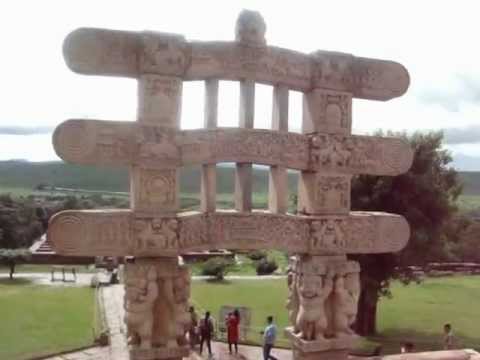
[0,161,480,195]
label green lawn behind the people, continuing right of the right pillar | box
[192,276,480,353]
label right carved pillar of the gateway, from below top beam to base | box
[286,89,360,360]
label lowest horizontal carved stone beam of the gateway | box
[48,210,410,257]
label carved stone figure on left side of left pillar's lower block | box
[125,266,158,349]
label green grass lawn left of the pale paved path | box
[0,279,94,360]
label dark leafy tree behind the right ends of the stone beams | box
[351,132,462,335]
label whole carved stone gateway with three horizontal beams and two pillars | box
[52,10,413,360]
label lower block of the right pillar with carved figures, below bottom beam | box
[285,255,360,360]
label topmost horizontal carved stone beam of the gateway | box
[63,28,410,101]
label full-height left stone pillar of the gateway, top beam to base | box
[125,34,190,360]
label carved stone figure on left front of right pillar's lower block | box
[296,272,333,340]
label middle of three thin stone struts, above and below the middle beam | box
[235,79,255,212]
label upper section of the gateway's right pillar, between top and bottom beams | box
[298,89,355,215]
